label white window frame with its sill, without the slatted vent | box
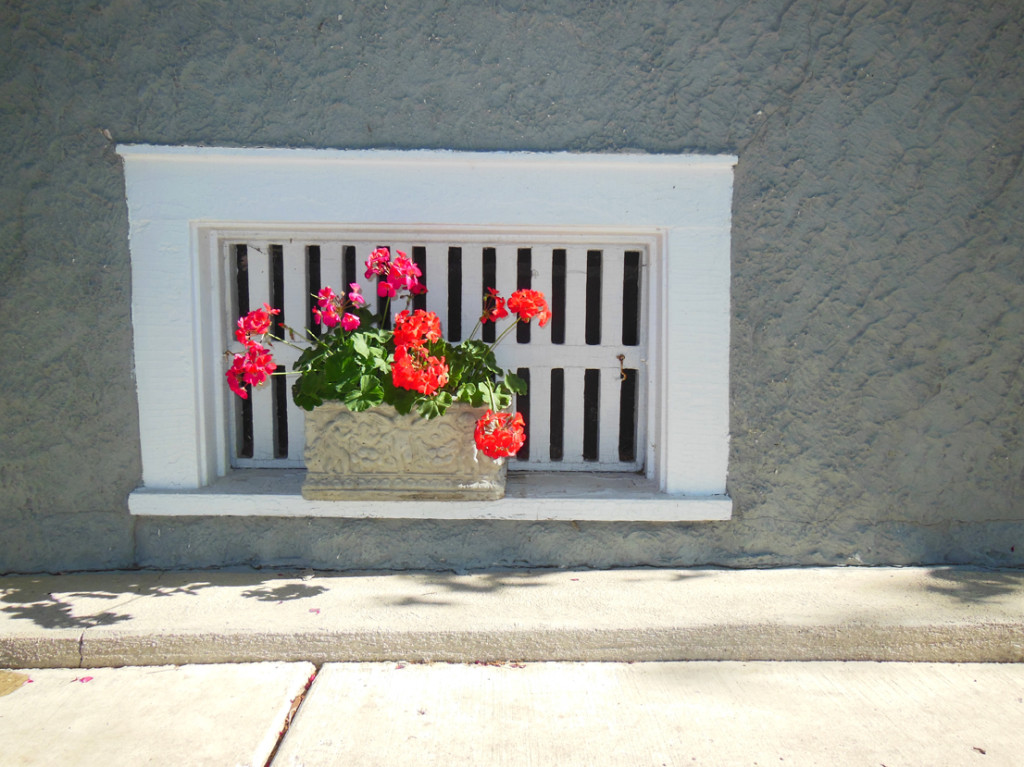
[118,145,736,521]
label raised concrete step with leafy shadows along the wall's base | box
[0,567,1024,669]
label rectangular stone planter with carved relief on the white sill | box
[302,402,507,501]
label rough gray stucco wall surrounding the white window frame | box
[0,0,1024,571]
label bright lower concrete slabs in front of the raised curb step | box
[0,662,1024,767]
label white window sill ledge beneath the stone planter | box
[128,469,732,522]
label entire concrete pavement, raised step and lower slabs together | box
[0,567,1024,767]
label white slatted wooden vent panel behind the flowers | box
[230,231,649,472]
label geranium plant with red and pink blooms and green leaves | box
[227,248,551,458]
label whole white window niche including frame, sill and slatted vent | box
[118,145,736,521]
